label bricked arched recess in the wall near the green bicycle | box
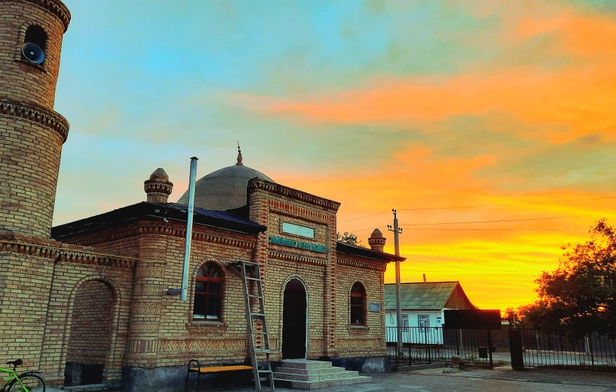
[64,280,115,386]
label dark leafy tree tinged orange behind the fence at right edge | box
[520,219,616,336]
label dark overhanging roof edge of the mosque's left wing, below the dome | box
[51,201,267,240]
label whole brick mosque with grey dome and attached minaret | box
[0,0,404,391]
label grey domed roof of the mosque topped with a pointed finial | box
[178,151,275,211]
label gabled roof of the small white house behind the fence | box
[385,282,475,310]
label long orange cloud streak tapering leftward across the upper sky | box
[243,61,616,143]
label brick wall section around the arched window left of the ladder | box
[157,227,256,366]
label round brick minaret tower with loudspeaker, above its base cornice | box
[0,0,71,238]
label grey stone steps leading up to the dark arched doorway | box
[274,359,372,389]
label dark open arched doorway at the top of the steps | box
[282,279,307,359]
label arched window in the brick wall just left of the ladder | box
[193,263,222,321]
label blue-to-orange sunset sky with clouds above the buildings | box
[54,0,616,310]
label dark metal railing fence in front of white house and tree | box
[386,327,616,371]
